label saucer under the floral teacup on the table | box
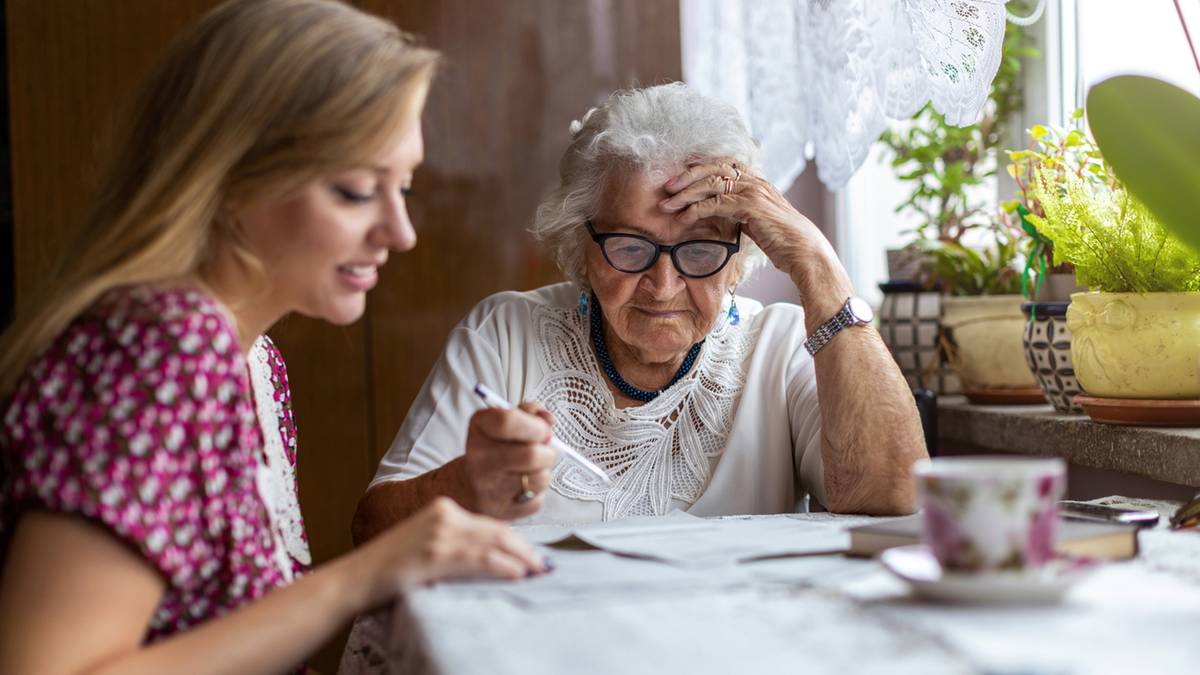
[880,544,1096,604]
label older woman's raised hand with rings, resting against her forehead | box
[659,159,836,283]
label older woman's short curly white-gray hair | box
[530,82,767,288]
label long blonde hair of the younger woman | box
[0,0,438,398]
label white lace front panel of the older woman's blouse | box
[533,306,751,520]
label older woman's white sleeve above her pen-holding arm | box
[367,324,509,489]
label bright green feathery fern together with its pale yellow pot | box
[1028,118,1200,422]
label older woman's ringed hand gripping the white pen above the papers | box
[464,402,558,519]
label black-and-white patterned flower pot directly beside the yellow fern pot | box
[1021,303,1084,413]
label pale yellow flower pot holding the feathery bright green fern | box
[1067,292,1200,399]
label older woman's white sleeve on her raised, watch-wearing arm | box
[787,345,827,504]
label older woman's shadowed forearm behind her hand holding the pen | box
[350,458,468,546]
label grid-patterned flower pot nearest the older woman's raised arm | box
[878,282,960,395]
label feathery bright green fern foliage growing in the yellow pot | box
[1028,168,1200,293]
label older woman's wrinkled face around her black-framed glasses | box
[587,167,738,364]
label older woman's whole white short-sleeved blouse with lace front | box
[371,278,824,522]
